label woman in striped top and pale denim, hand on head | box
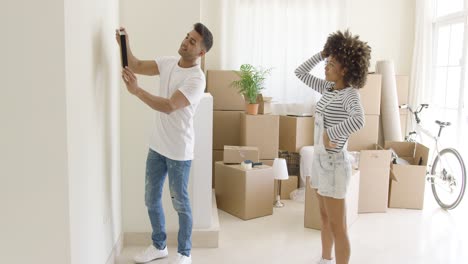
[295,31,371,264]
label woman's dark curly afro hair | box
[323,30,371,89]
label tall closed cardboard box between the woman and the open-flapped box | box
[359,149,391,213]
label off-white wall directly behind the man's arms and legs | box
[120,0,200,232]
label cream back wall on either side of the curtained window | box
[201,0,415,75]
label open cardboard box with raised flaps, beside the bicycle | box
[385,141,429,209]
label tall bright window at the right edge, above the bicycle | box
[432,0,468,146]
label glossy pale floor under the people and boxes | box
[116,185,468,264]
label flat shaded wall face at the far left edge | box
[0,0,70,264]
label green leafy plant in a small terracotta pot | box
[231,64,271,115]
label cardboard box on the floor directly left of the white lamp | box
[215,161,273,220]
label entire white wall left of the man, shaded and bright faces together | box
[0,0,121,264]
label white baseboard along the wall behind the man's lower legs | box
[124,190,219,248]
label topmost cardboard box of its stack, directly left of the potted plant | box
[206,70,245,111]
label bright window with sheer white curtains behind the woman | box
[221,0,346,105]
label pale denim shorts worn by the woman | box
[310,150,352,199]
